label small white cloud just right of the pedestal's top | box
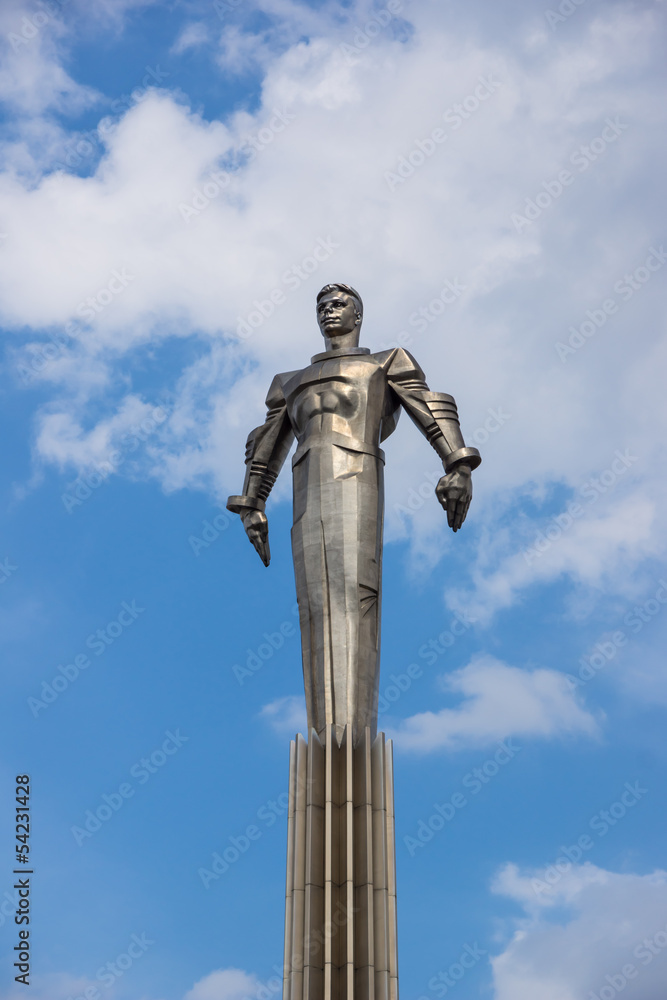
[392,656,599,753]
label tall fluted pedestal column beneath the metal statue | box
[283,727,398,1000]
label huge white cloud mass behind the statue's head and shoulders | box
[0,2,667,614]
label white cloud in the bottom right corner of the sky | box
[492,864,667,1000]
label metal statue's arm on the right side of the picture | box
[387,350,482,531]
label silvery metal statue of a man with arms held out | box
[227,284,481,746]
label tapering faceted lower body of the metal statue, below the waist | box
[292,444,383,741]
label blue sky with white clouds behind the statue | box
[0,0,667,1000]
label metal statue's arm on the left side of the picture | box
[227,375,294,566]
